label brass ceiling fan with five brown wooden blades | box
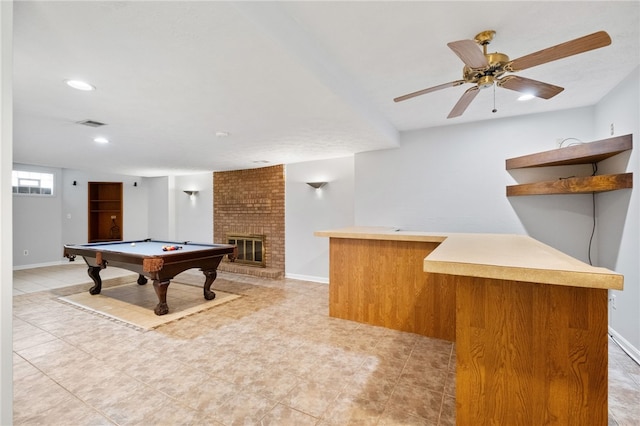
[394,30,611,118]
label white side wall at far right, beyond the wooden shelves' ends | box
[595,69,640,360]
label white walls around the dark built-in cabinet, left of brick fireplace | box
[9,170,213,269]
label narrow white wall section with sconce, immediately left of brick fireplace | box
[174,172,213,244]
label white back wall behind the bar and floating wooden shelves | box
[355,108,593,260]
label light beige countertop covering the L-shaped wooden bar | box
[314,227,624,290]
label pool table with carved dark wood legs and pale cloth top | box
[64,239,237,315]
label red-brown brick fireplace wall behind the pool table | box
[213,165,285,278]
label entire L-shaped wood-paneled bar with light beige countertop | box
[315,227,623,425]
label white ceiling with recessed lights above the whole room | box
[13,1,640,176]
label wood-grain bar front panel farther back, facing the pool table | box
[329,238,455,341]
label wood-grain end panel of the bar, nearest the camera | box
[456,277,608,425]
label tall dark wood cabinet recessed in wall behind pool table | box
[88,182,123,243]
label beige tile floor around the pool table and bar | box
[13,264,640,426]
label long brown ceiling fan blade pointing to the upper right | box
[505,31,611,71]
